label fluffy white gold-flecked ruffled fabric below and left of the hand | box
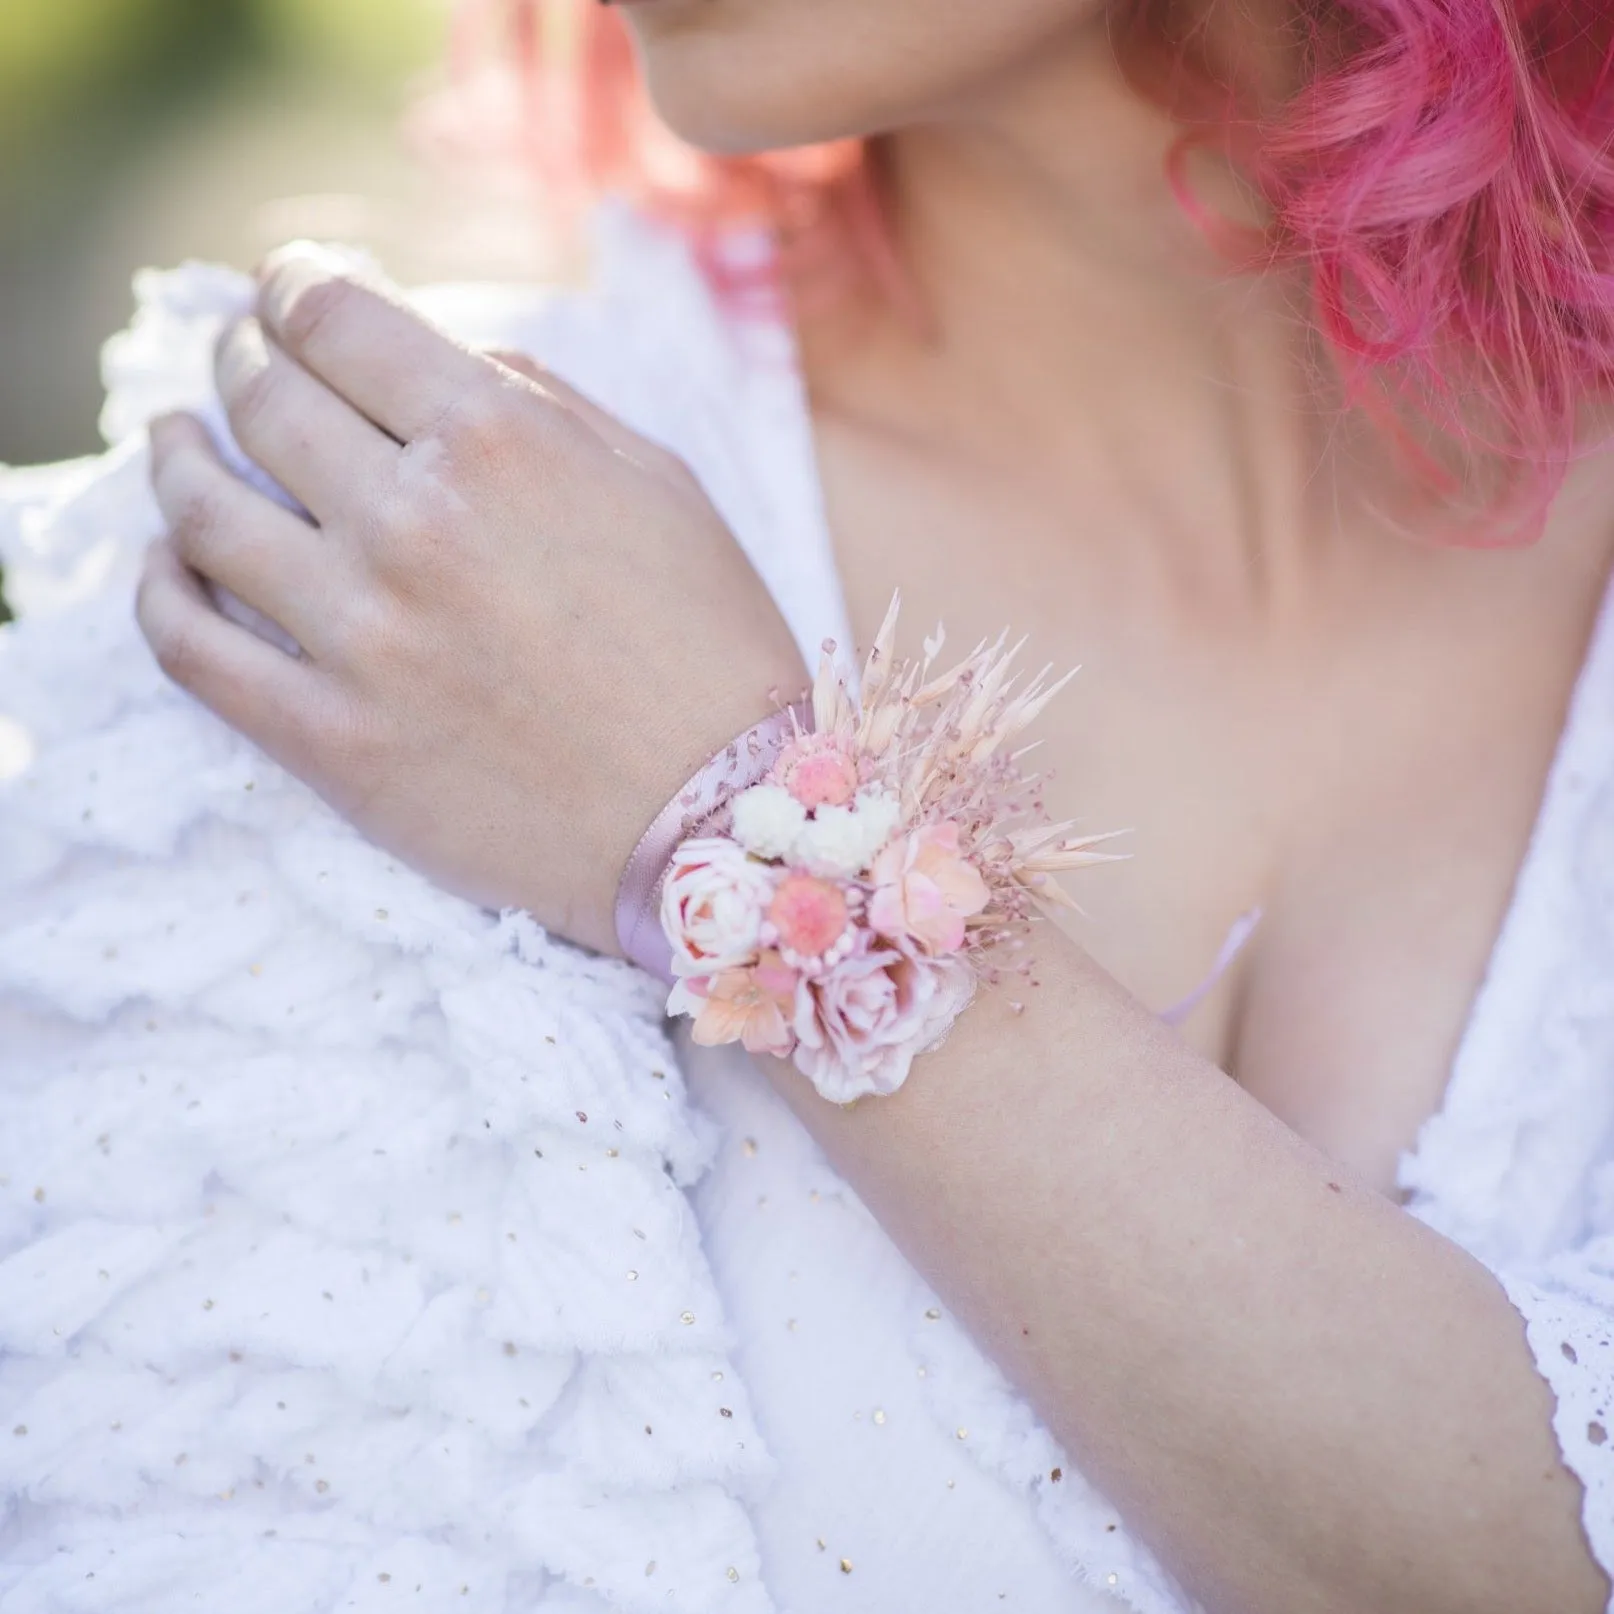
[0,230,778,1614]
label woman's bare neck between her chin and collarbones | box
[807,29,1375,603]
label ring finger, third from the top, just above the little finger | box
[152,415,336,655]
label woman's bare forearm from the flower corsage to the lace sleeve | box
[768,925,1609,1614]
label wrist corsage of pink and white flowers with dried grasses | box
[660,600,1104,1104]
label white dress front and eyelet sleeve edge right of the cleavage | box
[1399,574,1614,1611]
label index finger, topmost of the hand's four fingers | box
[258,242,497,442]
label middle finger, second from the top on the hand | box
[215,320,397,525]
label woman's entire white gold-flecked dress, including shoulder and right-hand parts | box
[0,201,1614,1614]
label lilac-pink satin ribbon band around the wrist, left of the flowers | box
[617,700,812,985]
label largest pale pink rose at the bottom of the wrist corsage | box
[794,944,975,1104]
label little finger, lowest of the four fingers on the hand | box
[134,541,329,762]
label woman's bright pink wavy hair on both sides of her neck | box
[457,0,1614,533]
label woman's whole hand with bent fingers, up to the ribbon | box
[137,247,805,951]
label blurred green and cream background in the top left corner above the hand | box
[0,0,542,465]
